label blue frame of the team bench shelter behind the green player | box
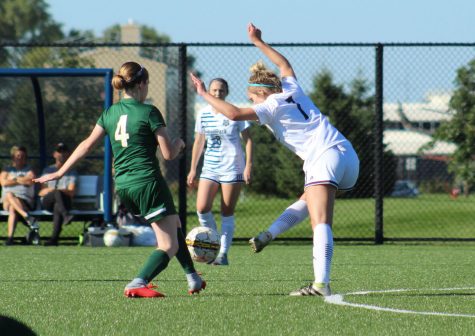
[0,68,113,223]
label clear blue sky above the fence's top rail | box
[46,0,475,43]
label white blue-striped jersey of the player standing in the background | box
[195,105,250,174]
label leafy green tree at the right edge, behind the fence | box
[431,59,475,194]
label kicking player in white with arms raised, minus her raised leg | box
[191,24,359,296]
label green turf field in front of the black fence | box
[0,243,475,336]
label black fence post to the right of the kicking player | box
[374,43,384,244]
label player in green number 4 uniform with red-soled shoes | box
[35,62,206,297]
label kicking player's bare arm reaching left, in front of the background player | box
[190,73,257,121]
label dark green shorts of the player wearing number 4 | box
[117,179,177,224]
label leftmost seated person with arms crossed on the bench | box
[0,146,38,245]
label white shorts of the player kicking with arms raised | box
[303,142,360,190]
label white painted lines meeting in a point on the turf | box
[325,287,475,317]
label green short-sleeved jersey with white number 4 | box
[97,98,165,189]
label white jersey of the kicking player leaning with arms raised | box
[252,77,348,160]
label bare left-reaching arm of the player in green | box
[33,125,105,183]
